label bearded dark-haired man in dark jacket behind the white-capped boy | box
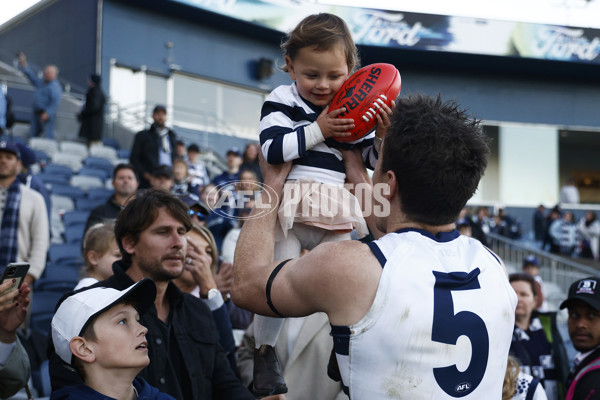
[50,190,253,400]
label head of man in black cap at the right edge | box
[560,276,600,353]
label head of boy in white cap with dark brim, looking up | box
[51,279,156,381]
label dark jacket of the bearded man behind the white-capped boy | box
[49,261,255,400]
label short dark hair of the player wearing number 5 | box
[381,94,489,225]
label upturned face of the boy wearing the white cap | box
[88,304,150,370]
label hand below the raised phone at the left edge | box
[0,281,31,343]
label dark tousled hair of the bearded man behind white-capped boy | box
[115,189,192,268]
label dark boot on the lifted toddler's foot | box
[252,345,287,397]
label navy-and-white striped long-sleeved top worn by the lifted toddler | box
[260,83,377,186]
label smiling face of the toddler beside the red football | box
[285,43,349,107]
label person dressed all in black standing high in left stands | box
[77,74,106,146]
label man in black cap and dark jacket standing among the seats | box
[129,105,177,189]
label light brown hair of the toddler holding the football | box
[281,13,360,72]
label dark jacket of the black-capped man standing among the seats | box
[129,124,177,189]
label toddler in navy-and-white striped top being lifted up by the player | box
[253,10,392,396]
